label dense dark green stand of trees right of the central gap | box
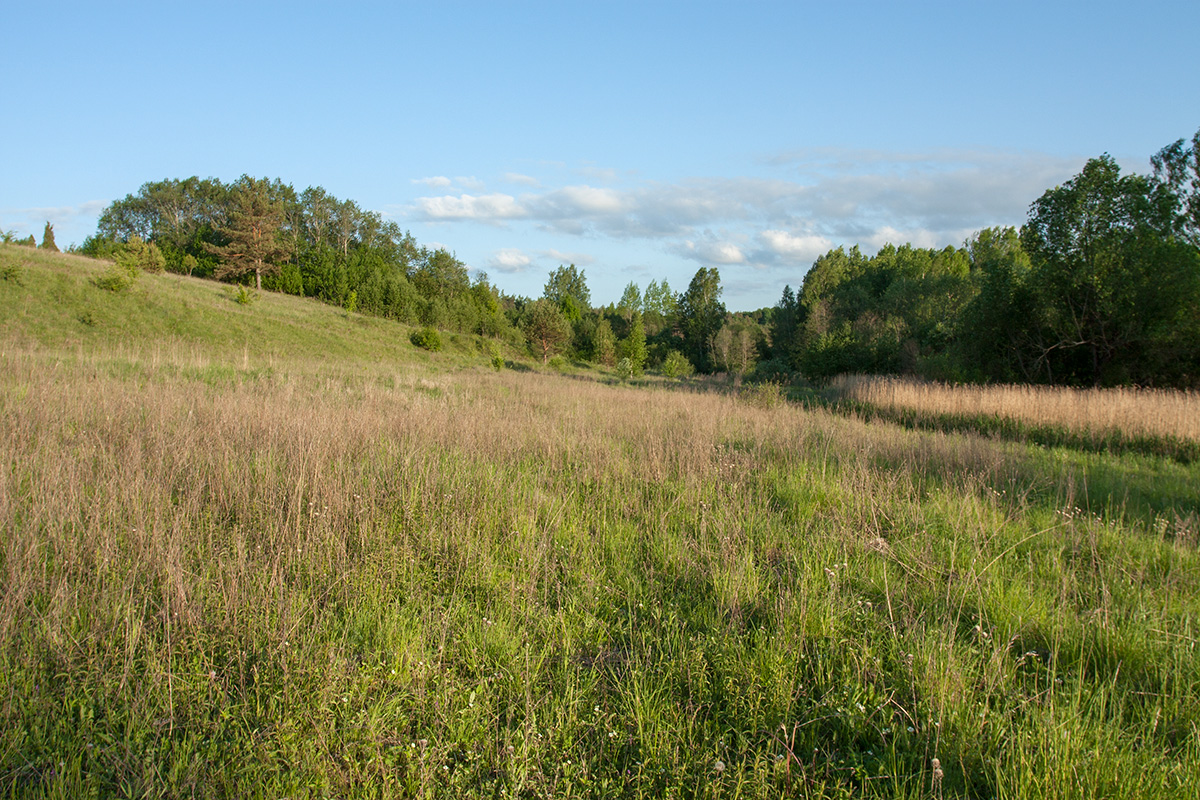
[763,132,1200,387]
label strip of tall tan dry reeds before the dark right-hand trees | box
[830,375,1200,441]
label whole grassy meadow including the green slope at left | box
[7,247,1200,798]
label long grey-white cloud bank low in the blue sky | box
[409,149,1082,275]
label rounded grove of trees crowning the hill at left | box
[79,175,520,338]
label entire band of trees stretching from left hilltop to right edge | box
[72,126,1200,387]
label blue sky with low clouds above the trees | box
[0,0,1200,311]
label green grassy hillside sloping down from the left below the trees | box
[0,245,511,371]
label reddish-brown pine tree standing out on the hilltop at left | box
[206,178,288,289]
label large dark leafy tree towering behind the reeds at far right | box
[1021,155,1200,385]
